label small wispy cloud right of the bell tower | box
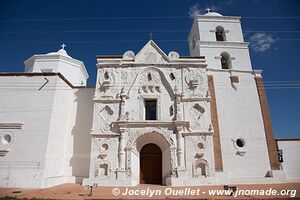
[249,33,276,52]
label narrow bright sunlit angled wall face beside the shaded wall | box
[43,77,73,187]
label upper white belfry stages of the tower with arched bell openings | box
[188,12,252,70]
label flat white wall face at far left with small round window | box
[0,75,57,188]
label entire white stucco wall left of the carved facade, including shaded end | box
[0,74,94,188]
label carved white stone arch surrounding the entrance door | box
[125,127,177,184]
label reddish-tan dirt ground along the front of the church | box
[0,183,300,199]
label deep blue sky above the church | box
[0,0,300,137]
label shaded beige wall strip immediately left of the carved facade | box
[70,88,95,184]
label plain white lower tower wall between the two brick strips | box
[212,72,270,178]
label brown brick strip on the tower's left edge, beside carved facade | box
[207,75,223,172]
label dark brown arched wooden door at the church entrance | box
[140,143,162,185]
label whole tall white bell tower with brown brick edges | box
[188,10,280,180]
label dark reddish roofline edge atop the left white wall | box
[0,72,95,89]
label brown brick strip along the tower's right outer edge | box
[255,77,280,170]
